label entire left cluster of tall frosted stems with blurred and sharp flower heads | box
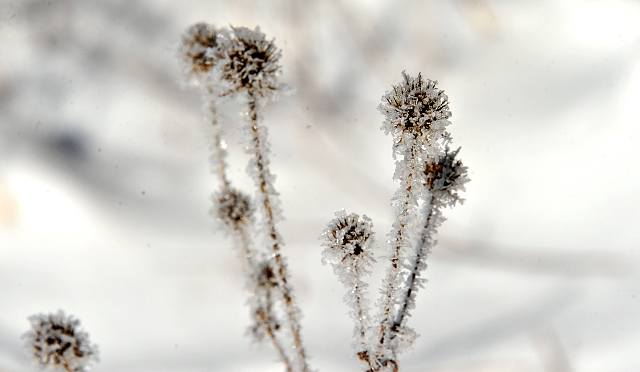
[179,23,308,372]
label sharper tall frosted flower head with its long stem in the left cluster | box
[232,28,309,372]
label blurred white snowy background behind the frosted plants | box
[0,0,640,372]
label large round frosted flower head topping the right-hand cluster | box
[378,71,451,154]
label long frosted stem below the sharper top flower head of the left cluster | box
[248,94,308,372]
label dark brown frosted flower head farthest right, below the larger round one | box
[424,146,469,206]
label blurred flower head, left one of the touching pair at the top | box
[180,23,228,79]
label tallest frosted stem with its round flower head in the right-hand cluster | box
[376,71,451,363]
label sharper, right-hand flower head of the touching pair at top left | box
[221,27,282,97]
